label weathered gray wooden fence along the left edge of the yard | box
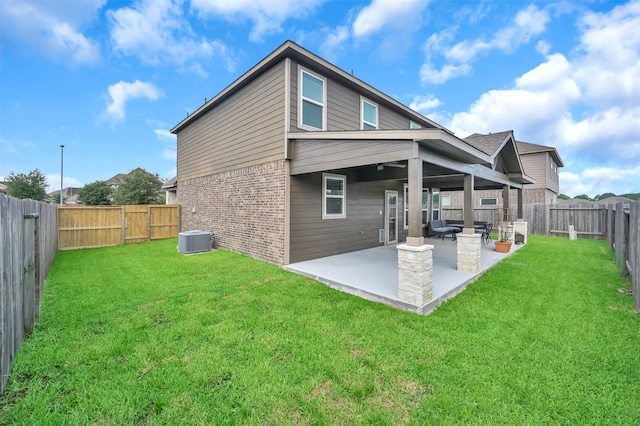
[0,194,58,394]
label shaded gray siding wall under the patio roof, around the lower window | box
[290,171,406,263]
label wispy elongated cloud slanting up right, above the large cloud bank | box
[420,5,550,84]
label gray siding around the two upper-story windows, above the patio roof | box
[290,61,424,131]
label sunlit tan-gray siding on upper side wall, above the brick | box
[178,62,285,181]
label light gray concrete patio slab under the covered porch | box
[285,238,522,314]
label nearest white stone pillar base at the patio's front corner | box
[397,244,433,306]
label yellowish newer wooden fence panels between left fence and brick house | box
[58,204,180,250]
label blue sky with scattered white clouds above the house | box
[0,0,640,196]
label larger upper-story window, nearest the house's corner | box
[298,69,327,130]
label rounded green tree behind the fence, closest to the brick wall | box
[113,168,164,204]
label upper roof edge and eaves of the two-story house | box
[171,40,444,134]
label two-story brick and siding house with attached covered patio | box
[171,41,533,264]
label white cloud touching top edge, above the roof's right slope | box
[353,0,427,37]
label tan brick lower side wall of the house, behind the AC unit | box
[178,161,286,265]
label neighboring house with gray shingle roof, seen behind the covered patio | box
[441,131,564,209]
